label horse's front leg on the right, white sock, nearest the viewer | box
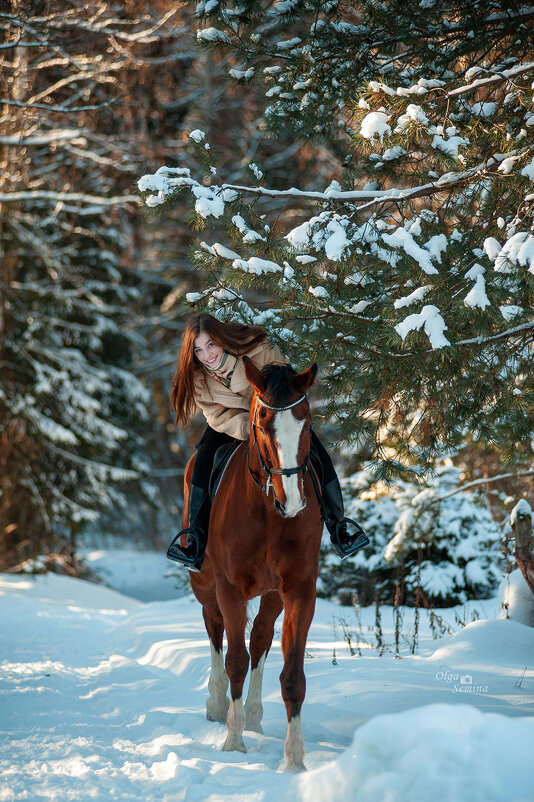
[280,581,315,771]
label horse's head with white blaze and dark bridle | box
[243,357,317,518]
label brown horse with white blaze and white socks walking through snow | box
[183,357,323,771]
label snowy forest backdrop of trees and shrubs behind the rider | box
[0,0,534,605]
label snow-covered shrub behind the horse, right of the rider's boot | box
[319,467,502,606]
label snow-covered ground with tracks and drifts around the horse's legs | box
[0,555,534,802]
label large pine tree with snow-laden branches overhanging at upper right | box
[139,0,534,478]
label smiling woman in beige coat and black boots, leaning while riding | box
[167,314,369,571]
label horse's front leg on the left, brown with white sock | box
[217,579,249,752]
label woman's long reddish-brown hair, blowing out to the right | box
[171,313,267,426]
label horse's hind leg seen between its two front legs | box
[245,590,283,732]
